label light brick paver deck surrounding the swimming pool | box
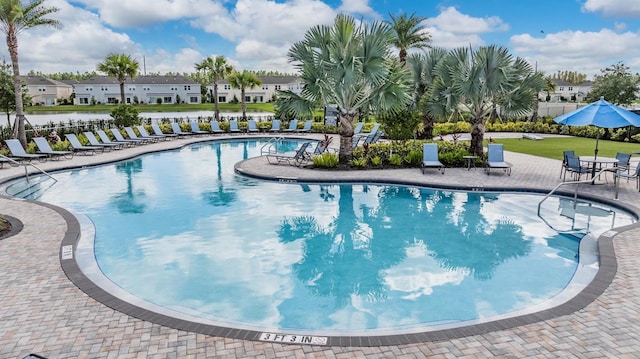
[0,136,640,358]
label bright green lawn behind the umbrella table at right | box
[494,137,640,160]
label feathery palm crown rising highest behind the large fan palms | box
[389,13,431,64]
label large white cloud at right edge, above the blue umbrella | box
[510,29,640,78]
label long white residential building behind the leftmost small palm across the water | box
[74,75,201,105]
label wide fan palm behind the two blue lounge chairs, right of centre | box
[425,45,546,156]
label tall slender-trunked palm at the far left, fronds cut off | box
[0,0,61,148]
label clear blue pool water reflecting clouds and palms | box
[7,140,634,333]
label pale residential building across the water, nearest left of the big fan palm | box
[207,76,302,103]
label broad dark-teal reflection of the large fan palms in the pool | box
[278,185,532,308]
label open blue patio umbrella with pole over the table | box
[553,97,640,157]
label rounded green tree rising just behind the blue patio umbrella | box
[586,62,640,105]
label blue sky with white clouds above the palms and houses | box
[8,0,640,79]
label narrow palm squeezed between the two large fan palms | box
[407,48,447,139]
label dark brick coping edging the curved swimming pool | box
[5,137,640,347]
